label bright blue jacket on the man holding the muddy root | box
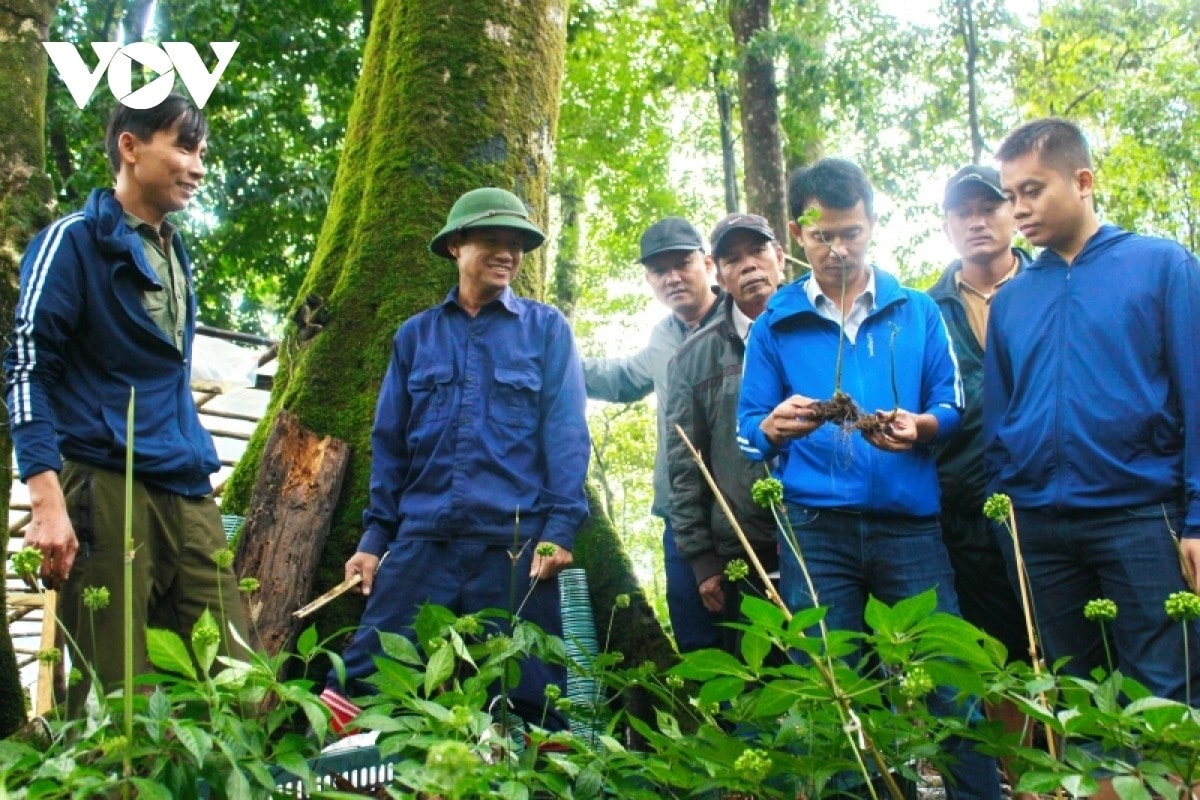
[738,267,962,517]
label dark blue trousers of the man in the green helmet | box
[328,539,568,730]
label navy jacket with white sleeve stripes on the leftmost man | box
[5,190,221,497]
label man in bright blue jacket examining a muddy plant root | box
[738,158,1000,799]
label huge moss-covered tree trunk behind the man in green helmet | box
[226,0,670,676]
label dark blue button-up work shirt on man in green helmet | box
[359,288,590,555]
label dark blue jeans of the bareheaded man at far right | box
[997,504,1200,705]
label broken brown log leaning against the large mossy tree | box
[234,411,350,655]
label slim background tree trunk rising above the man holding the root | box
[730,0,787,248]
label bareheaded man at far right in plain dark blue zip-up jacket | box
[983,119,1200,700]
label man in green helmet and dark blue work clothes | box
[323,188,590,729]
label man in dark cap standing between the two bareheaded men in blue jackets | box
[929,164,1030,796]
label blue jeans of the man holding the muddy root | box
[779,506,1000,800]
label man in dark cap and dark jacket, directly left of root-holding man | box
[667,213,784,652]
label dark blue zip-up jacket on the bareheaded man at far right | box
[983,225,1200,537]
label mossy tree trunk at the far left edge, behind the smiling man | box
[0,0,58,738]
